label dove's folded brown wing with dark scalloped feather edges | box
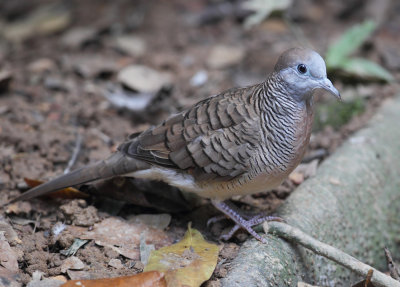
[120,86,260,180]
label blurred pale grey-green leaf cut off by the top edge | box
[242,0,292,28]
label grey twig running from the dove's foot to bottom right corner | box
[264,222,400,287]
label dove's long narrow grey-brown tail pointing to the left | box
[9,152,144,203]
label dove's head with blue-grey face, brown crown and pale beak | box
[274,48,340,101]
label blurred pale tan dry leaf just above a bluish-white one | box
[118,65,172,93]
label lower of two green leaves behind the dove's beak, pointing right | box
[342,58,393,82]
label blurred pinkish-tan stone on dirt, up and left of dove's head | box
[207,45,245,69]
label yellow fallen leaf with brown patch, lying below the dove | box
[144,224,219,287]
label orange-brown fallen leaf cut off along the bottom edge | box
[60,271,167,287]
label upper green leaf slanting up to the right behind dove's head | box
[326,20,376,69]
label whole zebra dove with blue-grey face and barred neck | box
[7,48,340,242]
